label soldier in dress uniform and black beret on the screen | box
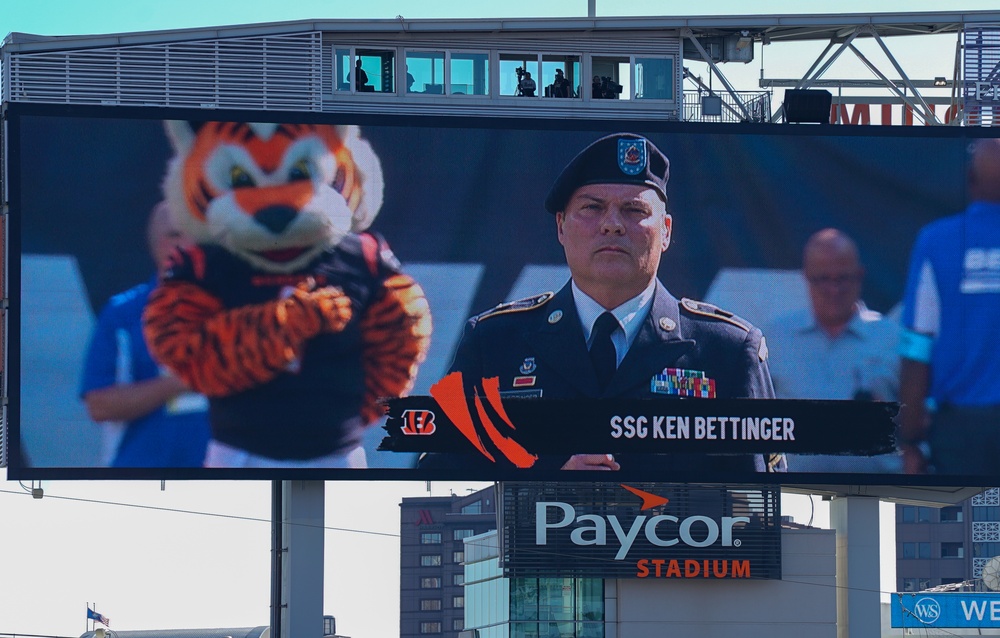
[421,133,782,478]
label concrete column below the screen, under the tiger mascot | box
[281,481,325,638]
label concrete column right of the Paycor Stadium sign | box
[830,496,882,638]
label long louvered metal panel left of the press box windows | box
[6,32,322,111]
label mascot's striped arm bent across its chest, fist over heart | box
[143,281,351,397]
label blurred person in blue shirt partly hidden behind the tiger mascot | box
[80,202,209,467]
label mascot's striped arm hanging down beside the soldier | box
[361,274,431,423]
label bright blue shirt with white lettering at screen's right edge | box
[901,202,1000,406]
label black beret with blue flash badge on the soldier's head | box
[545,133,670,215]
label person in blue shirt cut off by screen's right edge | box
[899,139,1000,477]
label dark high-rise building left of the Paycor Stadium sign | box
[399,486,497,638]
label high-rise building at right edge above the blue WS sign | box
[896,487,1000,592]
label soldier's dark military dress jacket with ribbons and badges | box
[421,282,774,476]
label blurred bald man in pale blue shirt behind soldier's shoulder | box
[764,228,901,473]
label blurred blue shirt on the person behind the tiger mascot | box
[80,278,209,467]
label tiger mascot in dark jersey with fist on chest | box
[143,121,431,467]
